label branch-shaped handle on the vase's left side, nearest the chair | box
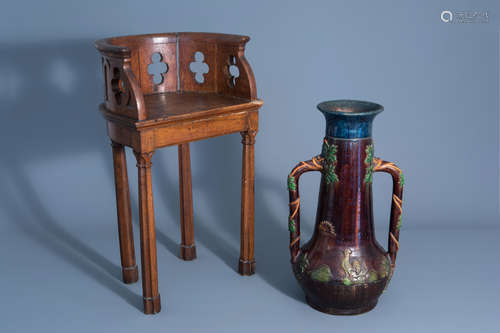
[288,155,324,263]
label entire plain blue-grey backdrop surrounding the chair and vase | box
[0,0,500,332]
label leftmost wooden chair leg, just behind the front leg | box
[111,141,139,283]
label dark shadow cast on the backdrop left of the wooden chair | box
[0,40,142,310]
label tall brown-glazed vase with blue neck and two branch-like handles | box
[288,100,404,315]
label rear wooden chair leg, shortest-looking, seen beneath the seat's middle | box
[178,143,196,260]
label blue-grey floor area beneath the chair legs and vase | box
[0,217,500,333]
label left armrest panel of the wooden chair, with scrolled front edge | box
[95,40,146,120]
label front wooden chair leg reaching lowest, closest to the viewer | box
[134,152,161,314]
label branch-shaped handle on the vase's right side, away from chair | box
[373,157,404,268]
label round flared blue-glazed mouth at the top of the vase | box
[318,99,384,116]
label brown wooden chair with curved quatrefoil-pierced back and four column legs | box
[95,33,262,314]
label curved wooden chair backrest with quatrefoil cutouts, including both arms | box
[96,32,257,120]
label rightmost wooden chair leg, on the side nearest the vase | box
[238,131,257,275]
